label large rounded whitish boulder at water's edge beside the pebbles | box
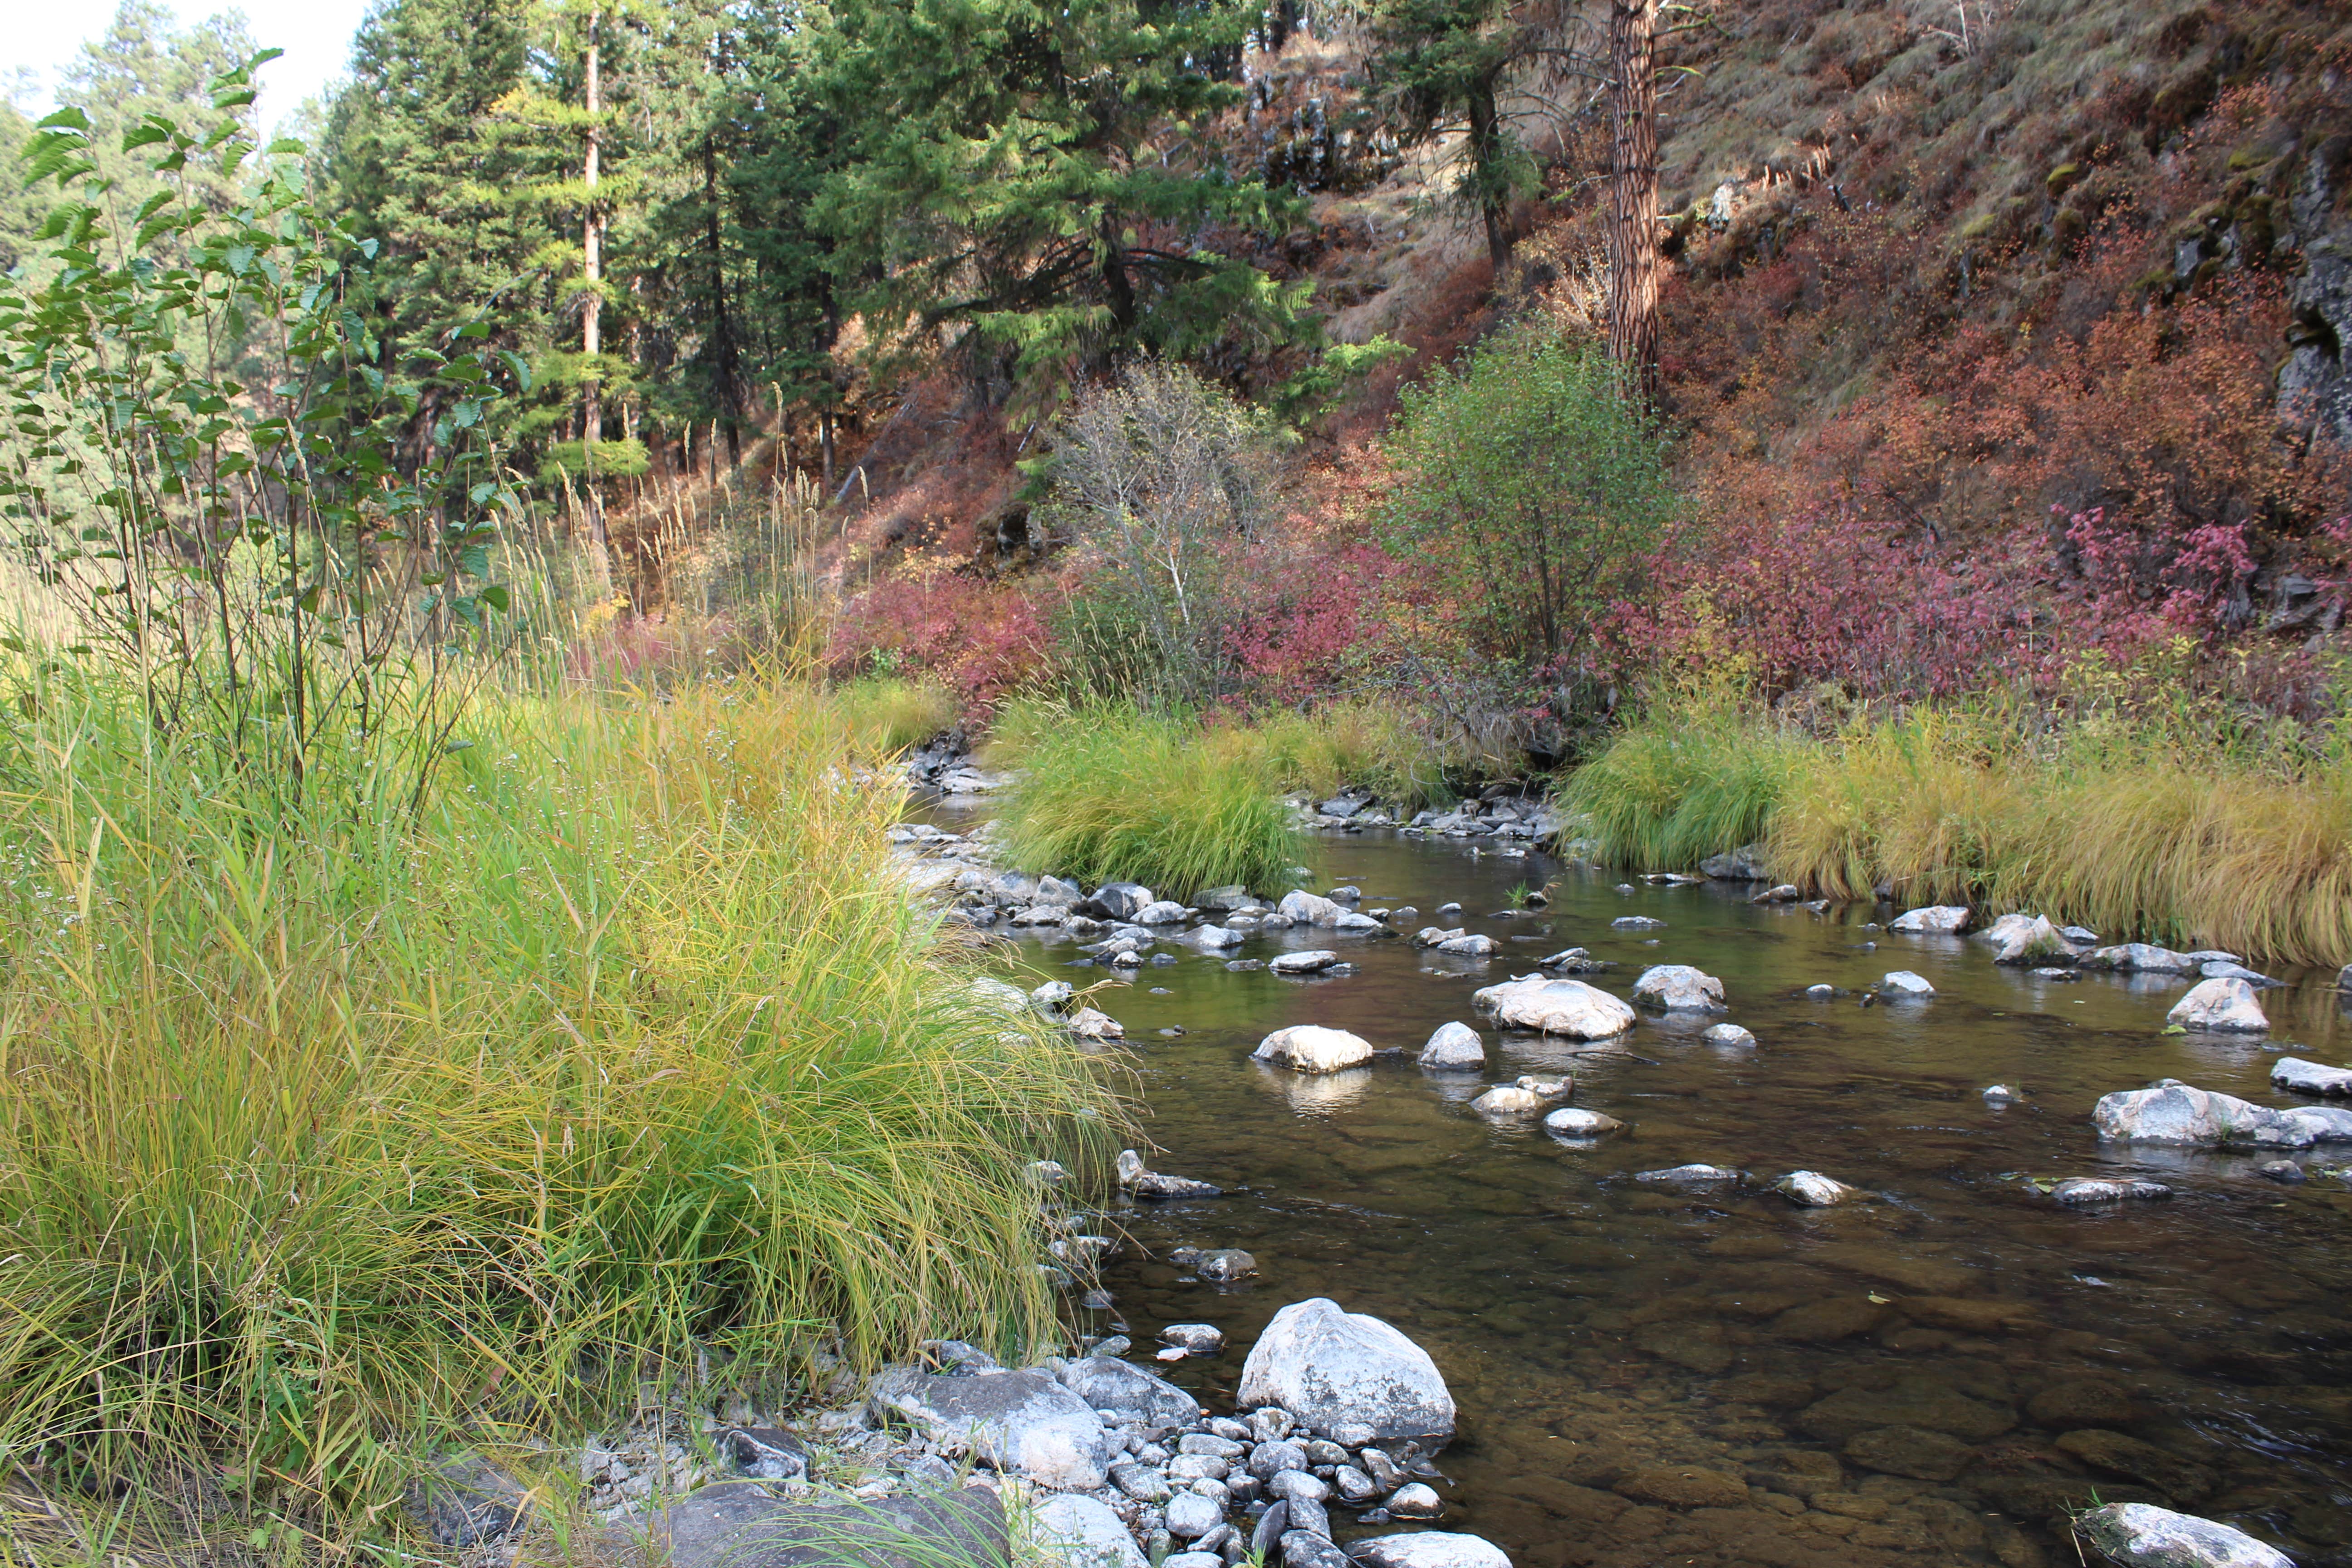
[1235,1295,1454,1439]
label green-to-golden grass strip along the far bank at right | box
[1564,703,2352,966]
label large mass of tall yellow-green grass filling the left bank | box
[0,682,1120,1542]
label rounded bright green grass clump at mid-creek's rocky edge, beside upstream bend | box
[993,701,1305,898]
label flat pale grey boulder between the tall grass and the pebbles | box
[868,1366,1112,1490]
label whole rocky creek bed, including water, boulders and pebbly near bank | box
[416,799,2352,1568]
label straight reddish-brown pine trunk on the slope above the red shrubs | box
[1609,0,1658,404]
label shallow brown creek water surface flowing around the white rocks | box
[938,813,2352,1568]
